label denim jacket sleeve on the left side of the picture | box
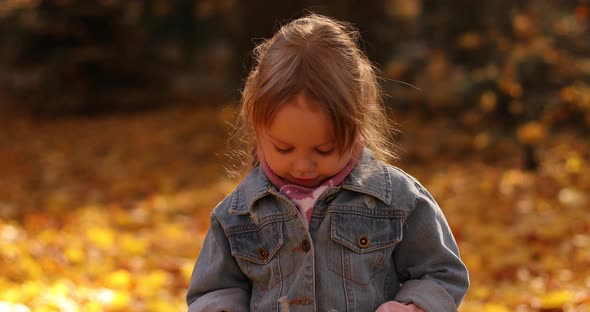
[186,215,250,312]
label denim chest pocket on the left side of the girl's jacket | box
[228,222,283,291]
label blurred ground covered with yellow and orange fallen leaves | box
[0,103,590,312]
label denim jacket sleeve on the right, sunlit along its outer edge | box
[394,184,469,312]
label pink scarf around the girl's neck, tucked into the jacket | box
[260,157,356,225]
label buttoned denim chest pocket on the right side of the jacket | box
[330,212,404,285]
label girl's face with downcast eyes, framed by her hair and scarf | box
[258,95,352,187]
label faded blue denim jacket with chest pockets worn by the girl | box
[187,149,469,312]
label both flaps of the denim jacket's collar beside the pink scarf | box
[230,148,392,215]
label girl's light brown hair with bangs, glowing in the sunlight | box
[234,13,396,173]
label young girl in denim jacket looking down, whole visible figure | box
[187,14,469,312]
